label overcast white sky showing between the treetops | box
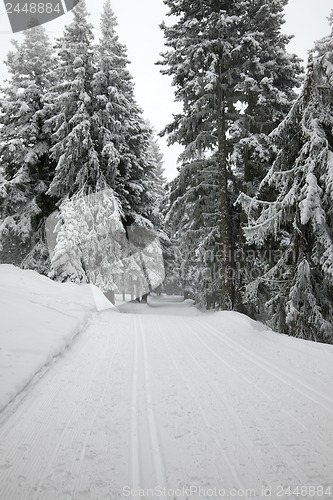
[0,0,333,180]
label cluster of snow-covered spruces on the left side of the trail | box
[0,0,167,298]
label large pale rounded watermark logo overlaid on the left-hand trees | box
[45,188,165,301]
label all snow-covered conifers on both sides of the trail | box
[0,0,333,343]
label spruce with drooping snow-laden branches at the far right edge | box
[239,17,333,343]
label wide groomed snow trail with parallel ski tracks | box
[0,303,333,500]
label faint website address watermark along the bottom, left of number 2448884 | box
[122,485,258,500]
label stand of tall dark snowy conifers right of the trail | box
[159,0,333,343]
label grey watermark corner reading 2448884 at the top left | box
[4,0,80,33]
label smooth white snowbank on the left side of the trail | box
[0,265,113,410]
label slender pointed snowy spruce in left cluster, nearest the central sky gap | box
[92,0,169,295]
